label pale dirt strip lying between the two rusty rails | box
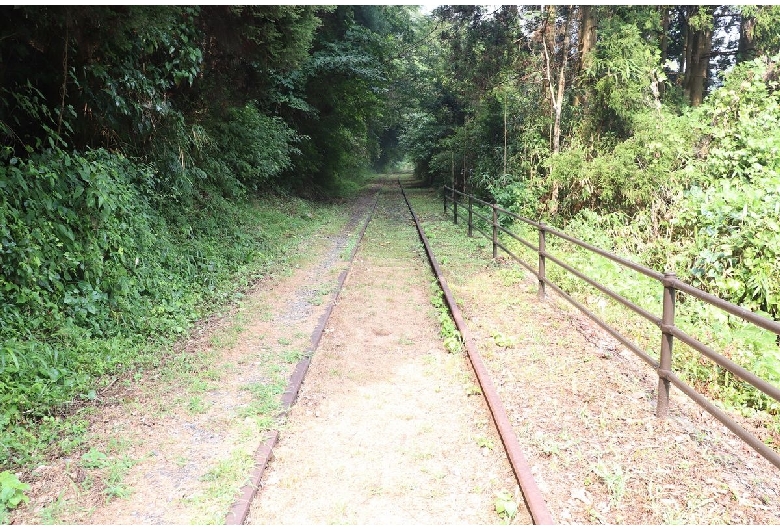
[247,178,528,524]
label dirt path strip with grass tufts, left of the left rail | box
[12,184,376,524]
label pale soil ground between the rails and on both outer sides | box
[11,175,780,524]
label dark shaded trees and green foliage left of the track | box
[0,5,414,466]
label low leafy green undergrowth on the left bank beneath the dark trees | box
[0,146,348,469]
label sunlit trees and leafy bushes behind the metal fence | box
[401,6,780,420]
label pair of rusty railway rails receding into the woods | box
[225,175,553,524]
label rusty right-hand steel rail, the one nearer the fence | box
[406,179,554,524]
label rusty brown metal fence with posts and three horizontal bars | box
[444,186,780,468]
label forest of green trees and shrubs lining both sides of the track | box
[0,5,780,488]
